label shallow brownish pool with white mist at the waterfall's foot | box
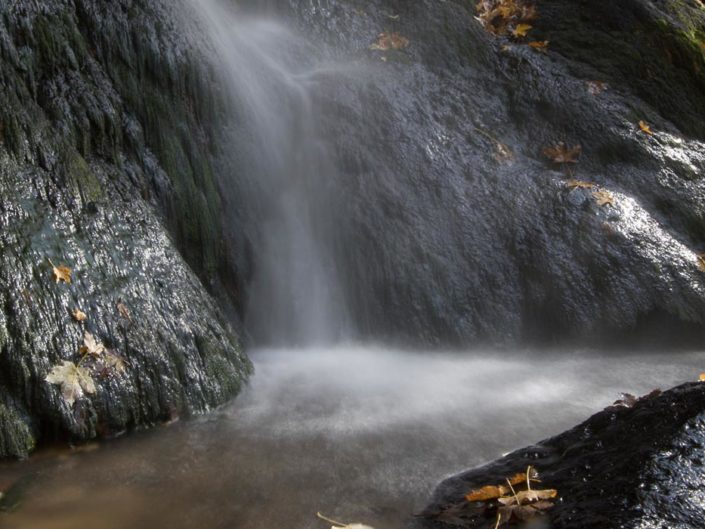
[0,347,705,529]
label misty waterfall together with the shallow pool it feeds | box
[0,0,702,529]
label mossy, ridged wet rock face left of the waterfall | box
[0,0,251,457]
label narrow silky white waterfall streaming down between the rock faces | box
[193,0,345,345]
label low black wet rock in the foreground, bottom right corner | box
[408,383,705,529]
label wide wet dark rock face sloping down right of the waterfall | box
[254,0,705,344]
